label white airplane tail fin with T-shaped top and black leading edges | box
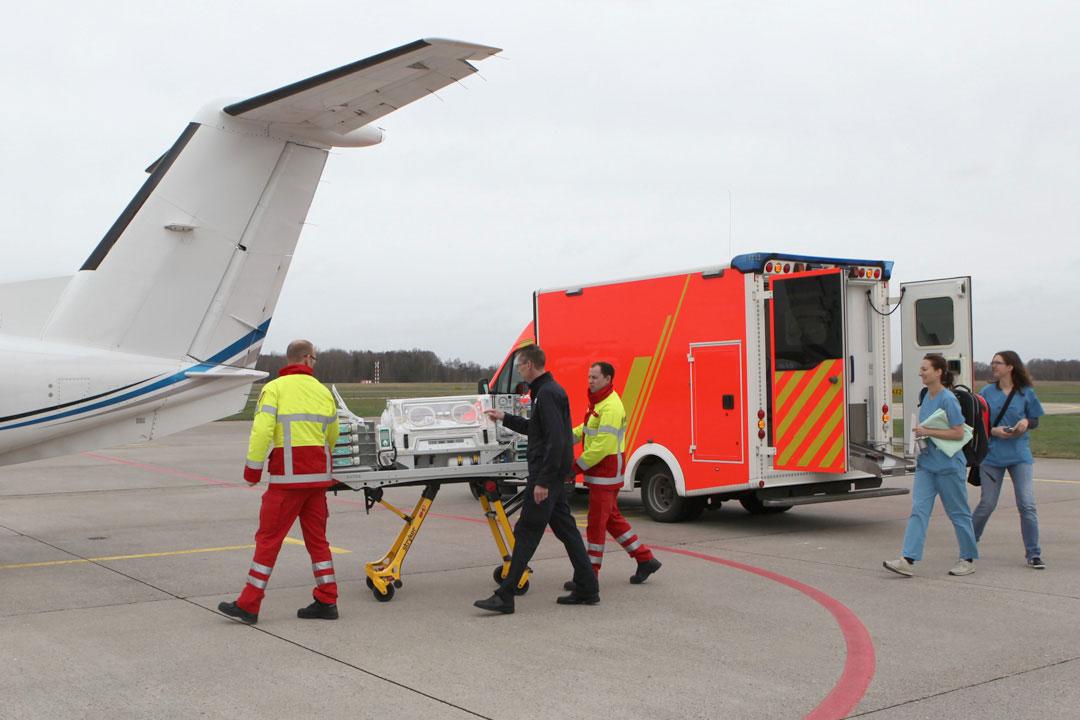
[42,40,499,367]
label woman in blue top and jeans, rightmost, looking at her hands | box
[972,350,1047,570]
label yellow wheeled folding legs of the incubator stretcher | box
[364,481,531,602]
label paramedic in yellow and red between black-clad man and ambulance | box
[566,362,660,589]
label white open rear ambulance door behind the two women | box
[900,277,974,448]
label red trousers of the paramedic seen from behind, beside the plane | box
[237,485,337,614]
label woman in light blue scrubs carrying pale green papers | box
[881,354,978,578]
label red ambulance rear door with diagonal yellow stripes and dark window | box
[769,268,848,473]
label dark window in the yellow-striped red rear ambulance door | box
[772,274,843,370]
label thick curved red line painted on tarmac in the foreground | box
[651,545,876,720]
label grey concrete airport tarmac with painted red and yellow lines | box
[0,423,1080,720]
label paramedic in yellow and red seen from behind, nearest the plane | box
[218,340,338,624]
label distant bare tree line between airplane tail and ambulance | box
[255,348,496,382]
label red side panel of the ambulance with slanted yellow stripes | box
[536,270,750,494]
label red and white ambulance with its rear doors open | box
[482,253,972,521]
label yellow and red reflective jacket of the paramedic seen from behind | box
[244,365,338,488]
